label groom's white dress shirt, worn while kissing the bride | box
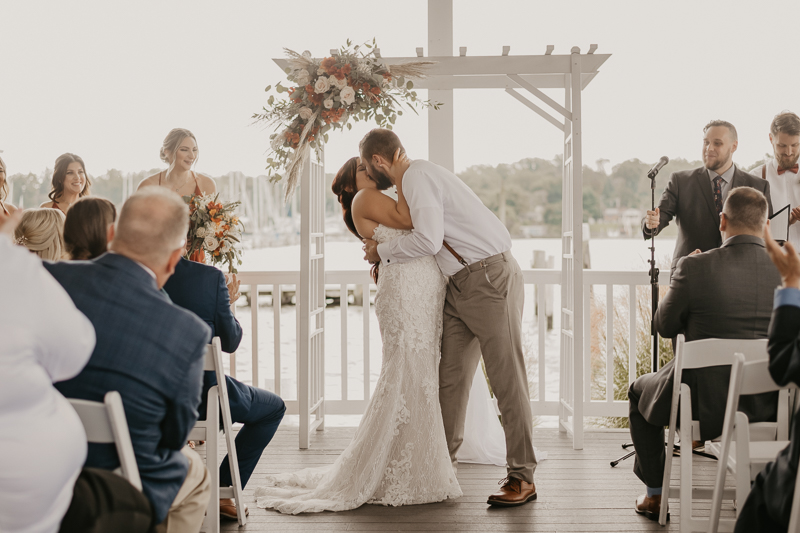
[378,160,511,276]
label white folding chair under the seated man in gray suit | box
[658,335,767,532]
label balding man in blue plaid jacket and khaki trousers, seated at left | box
[45,187,211,531]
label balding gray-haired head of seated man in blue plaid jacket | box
[109,187,189,270]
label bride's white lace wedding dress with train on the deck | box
[255,225,461,514]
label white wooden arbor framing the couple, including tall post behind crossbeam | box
[274,0,611,449]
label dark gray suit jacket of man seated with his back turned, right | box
[639,235,781,440]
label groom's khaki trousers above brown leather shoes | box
[439,252,536,483]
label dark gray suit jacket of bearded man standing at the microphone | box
[642,167,772,274]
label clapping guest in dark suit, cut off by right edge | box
[734,230,800,533]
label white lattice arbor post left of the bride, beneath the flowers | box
[296,151,325,450]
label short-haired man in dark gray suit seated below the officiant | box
[628,187,780,520]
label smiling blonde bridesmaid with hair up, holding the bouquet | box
[138,128,217,196]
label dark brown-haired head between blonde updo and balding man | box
[64,196,117,261]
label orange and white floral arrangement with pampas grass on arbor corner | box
[253,39,440,200]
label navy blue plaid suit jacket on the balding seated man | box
[44,253,211,523]
